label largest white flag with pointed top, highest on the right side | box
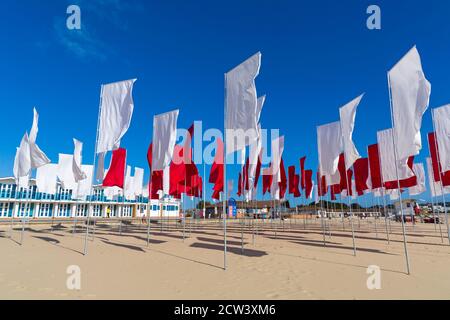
[383,46,431,160]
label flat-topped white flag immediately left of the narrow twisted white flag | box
[317,121,343,176]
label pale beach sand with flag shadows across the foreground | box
[0,219,450,300]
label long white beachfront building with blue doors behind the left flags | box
[0,178,181,219]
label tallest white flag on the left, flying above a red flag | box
[97,79,137,153]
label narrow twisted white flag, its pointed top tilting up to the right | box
[339,94,364,169]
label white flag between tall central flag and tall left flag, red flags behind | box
[152,110,179,171]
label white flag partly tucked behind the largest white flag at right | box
[377,129,414,182]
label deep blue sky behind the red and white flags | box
[0,0,450,204]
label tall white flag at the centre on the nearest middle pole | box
[225,52,261,154]
